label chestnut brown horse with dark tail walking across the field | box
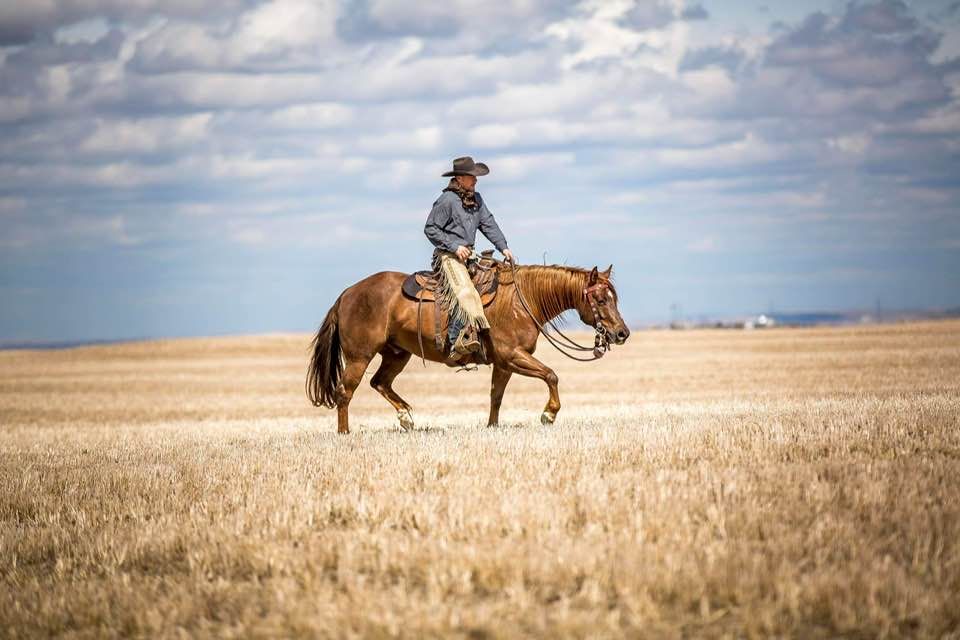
[306,263,630,433]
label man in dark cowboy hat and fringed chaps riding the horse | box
[423,156,513,355]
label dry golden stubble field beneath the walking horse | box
[0,322,960,638]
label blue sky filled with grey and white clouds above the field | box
[0,0,960,341]
